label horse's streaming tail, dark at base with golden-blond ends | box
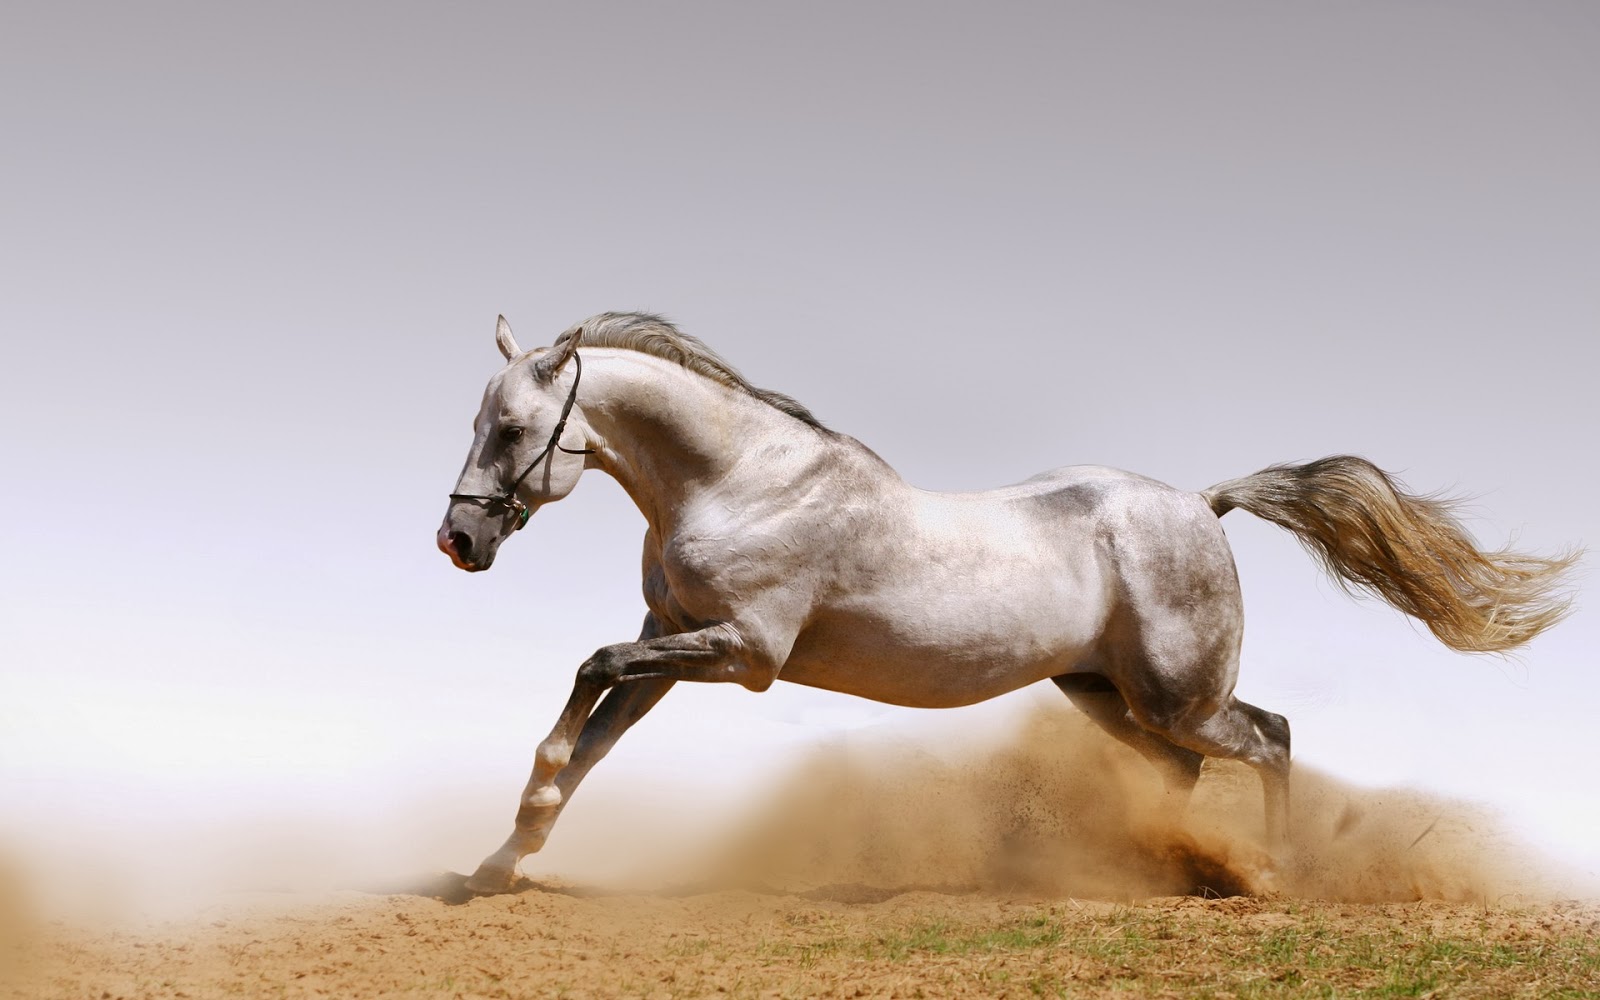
[1202,454,1581,653]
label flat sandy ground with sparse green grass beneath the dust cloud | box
[12,878,1600,1000]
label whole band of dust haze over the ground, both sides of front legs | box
[0,706,1597,939]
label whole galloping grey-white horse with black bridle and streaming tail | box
[438,314,1576,893]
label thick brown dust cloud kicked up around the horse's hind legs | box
[694,709,1573,906]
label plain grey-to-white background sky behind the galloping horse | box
[0,2,1600,902]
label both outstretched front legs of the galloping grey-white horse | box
[467,618,771,893]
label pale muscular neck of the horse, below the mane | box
[579,350,826,534]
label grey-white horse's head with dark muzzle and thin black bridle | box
[438,317,589,571]
